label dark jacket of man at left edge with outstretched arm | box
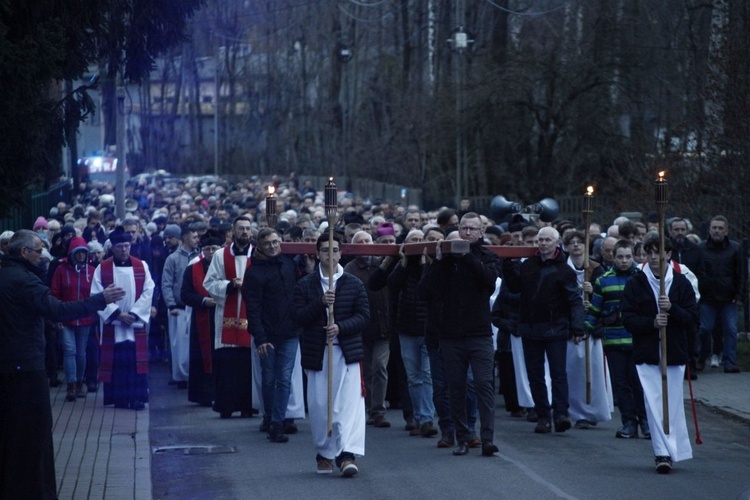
[0,256,107,373]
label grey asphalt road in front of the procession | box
[149,365,750,500]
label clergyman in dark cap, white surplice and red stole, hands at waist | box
[91,226,155,410]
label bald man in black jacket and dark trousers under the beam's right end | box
[503,227,584,434]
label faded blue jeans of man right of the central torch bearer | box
[399,334,435,425]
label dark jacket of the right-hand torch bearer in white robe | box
[620,273,698,365]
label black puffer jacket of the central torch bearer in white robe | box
[290,264,370,371]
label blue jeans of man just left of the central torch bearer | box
[260,337,299,425]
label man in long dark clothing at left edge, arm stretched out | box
[0,229,125,498]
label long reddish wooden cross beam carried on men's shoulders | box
[281,240,537,259]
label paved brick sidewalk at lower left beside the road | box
[50,384,151,500]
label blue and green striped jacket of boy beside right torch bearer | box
[584,265,639,349]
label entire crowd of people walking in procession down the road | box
[0,172,747,498]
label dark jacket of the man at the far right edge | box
[700,238,745,304]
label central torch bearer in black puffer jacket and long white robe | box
[290,235,370,477]
